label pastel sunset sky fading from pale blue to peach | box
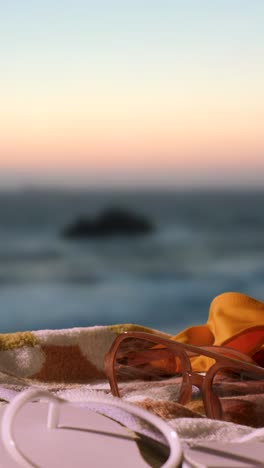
[0,0,264,188]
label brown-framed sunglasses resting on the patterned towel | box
[104,332,264,427]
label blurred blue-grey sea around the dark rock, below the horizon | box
[0,190,264,334]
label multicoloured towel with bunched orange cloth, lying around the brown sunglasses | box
[0,293,264,452]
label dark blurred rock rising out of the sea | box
[63,209,154,239]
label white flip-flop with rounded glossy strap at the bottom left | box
[0,389,182,468]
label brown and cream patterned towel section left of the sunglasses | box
[0,324,169,400]
